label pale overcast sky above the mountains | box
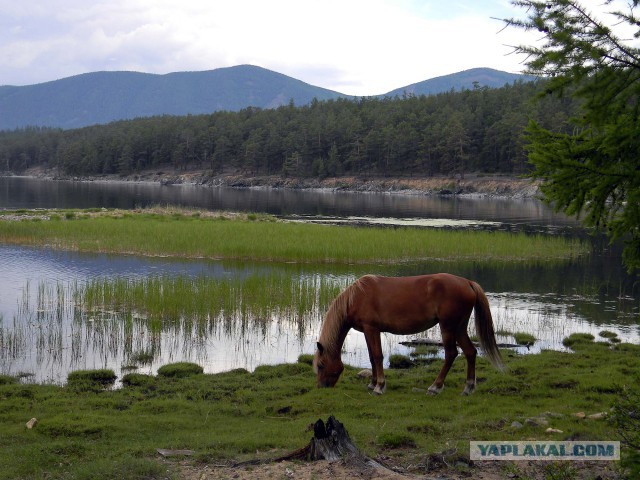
[0,0,612,95]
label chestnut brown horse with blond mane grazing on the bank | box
[313,273,504,395]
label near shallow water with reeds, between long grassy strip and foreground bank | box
[0,247,639,383]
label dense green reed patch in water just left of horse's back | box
[77,274,346,332]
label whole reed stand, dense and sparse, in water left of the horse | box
[0,271,353,382]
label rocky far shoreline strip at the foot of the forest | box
[8,167,540,199]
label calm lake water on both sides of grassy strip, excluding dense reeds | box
[0,178,640,382]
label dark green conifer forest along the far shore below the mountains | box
[0,82,576,177]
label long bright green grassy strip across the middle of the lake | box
[0,207,588,264]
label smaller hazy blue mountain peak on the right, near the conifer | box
[385,68,535,97]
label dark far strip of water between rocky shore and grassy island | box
[0,177,577,227]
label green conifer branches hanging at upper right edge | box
[505,0,640,270]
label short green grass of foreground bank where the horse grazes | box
[0,339,640,479]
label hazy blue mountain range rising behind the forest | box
[0,65,533,130]
